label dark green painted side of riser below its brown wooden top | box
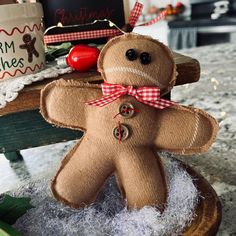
[0,109,83,153]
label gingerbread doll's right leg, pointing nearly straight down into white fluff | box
[116,148,167,210]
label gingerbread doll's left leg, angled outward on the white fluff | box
[52,138,114,208]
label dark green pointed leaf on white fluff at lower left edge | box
[0,195,33,226]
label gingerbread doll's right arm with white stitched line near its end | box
[155,105,218,155]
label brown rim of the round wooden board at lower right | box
[181,159,222,236]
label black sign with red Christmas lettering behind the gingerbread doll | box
[40,0,130,44]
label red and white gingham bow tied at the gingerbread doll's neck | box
[85,83,176,109]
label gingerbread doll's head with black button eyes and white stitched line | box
[98,34,176,94]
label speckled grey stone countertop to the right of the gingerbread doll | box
[172,44,236,235]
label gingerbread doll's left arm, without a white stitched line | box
[40,79,102,130]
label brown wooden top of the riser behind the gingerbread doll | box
[0,53,200,116]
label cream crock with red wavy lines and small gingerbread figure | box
[0,3,45,80]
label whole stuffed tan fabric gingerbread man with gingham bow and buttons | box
[41,33,218,209]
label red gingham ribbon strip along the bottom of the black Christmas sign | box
[44,29,122,44]
